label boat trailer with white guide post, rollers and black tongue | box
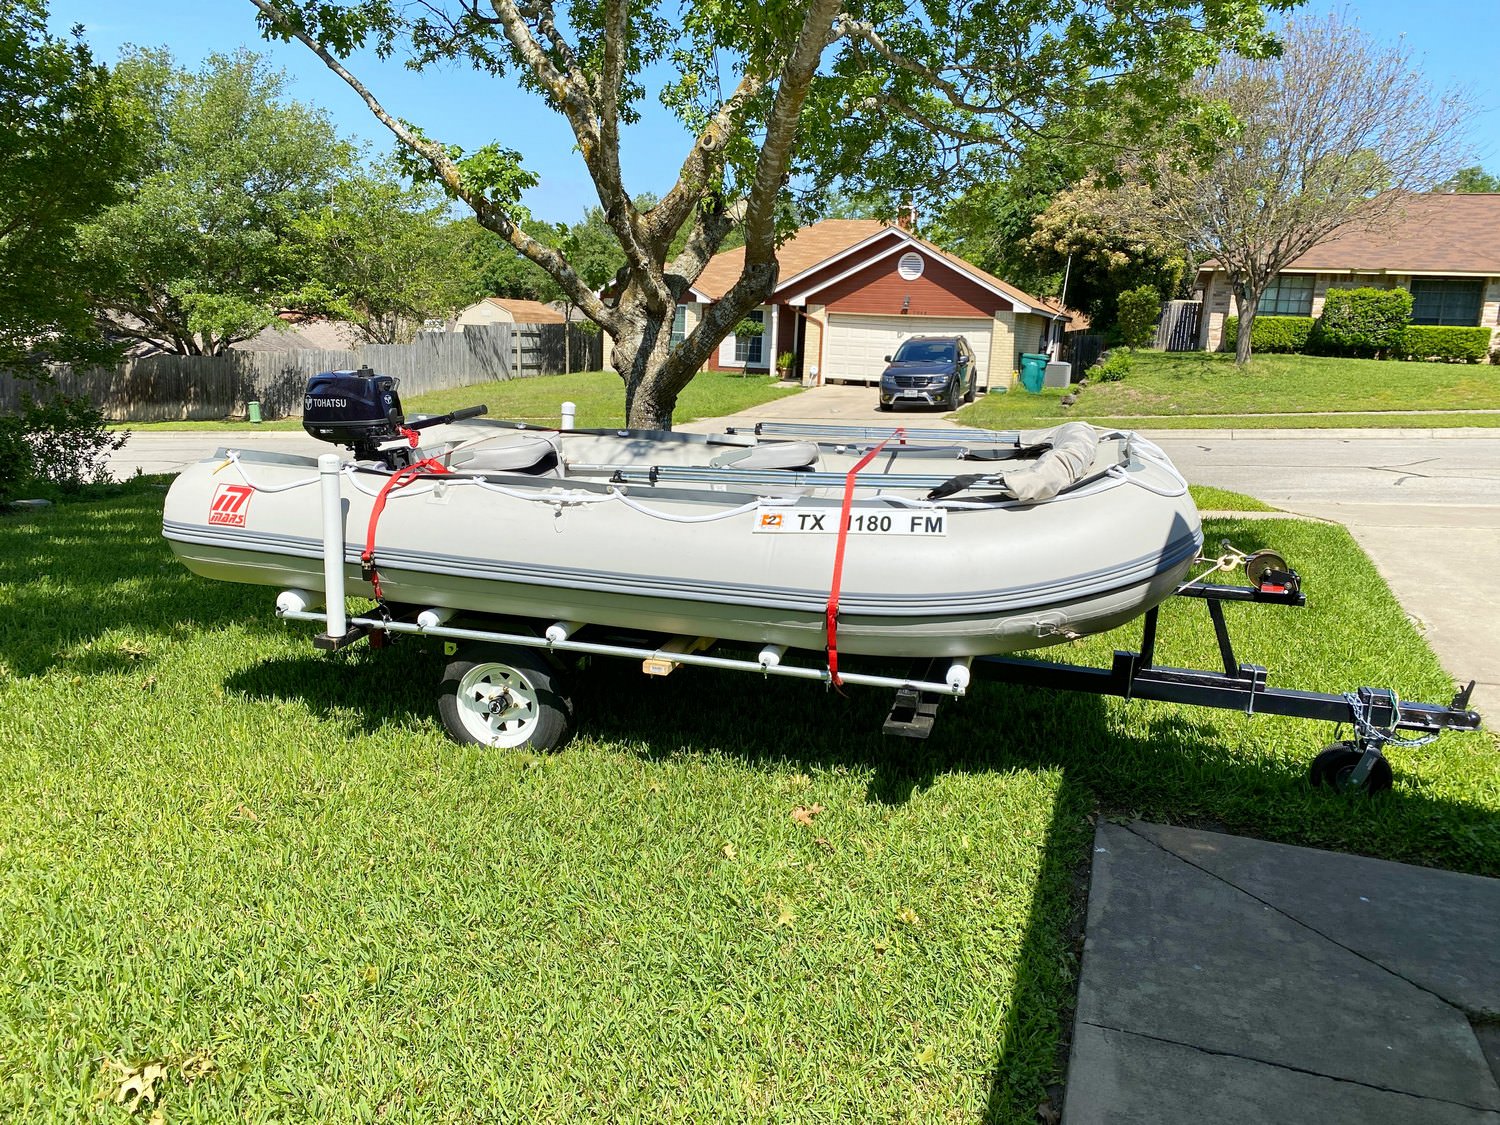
[276,501,1481,792]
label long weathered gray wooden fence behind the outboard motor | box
[0,324,603,422]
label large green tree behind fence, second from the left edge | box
[81,51,354,356]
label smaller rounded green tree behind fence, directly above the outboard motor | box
[291,168,485,344]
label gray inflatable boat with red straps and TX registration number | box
[164,395,1202,657]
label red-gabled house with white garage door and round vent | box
[672,219,1067,389]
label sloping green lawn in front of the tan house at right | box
[959,351,1500,429]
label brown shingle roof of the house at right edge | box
[1248,192,1500,278]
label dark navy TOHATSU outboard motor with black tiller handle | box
[302,368,488,470]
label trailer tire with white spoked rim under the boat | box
[438,645,573,750]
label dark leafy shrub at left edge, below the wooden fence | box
[0,395,131,500]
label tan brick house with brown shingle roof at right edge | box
[1196,192,1500,351]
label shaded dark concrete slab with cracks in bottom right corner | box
[1064,822,1500,1125]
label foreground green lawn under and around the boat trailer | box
[0,480,1500,1125]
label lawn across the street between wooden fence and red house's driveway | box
[122,371,801,432]
